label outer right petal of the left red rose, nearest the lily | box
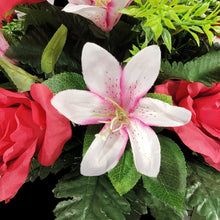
[31,84,72,166]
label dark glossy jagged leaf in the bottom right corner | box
[185,160,220,220]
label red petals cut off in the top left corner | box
[0,0,46,20]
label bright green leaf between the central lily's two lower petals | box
[108,145,141,195]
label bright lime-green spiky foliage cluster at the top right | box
[121,0,220,51]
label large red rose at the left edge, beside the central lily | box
[0,84,72,202]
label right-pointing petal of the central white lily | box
[130,98,191,127]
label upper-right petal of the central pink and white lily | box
[121,45,161,111]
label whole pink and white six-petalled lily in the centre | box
[52,43,191,177]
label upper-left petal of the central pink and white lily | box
[82,43,122,104]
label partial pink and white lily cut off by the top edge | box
[63,0,133,31]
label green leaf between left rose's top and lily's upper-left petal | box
[43,73,87,93]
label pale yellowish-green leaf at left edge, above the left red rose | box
[0,57,42,92]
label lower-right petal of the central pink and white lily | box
[127,119,161,177]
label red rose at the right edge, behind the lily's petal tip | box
[155,81,220,171]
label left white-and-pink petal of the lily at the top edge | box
[63,3,107,30]
